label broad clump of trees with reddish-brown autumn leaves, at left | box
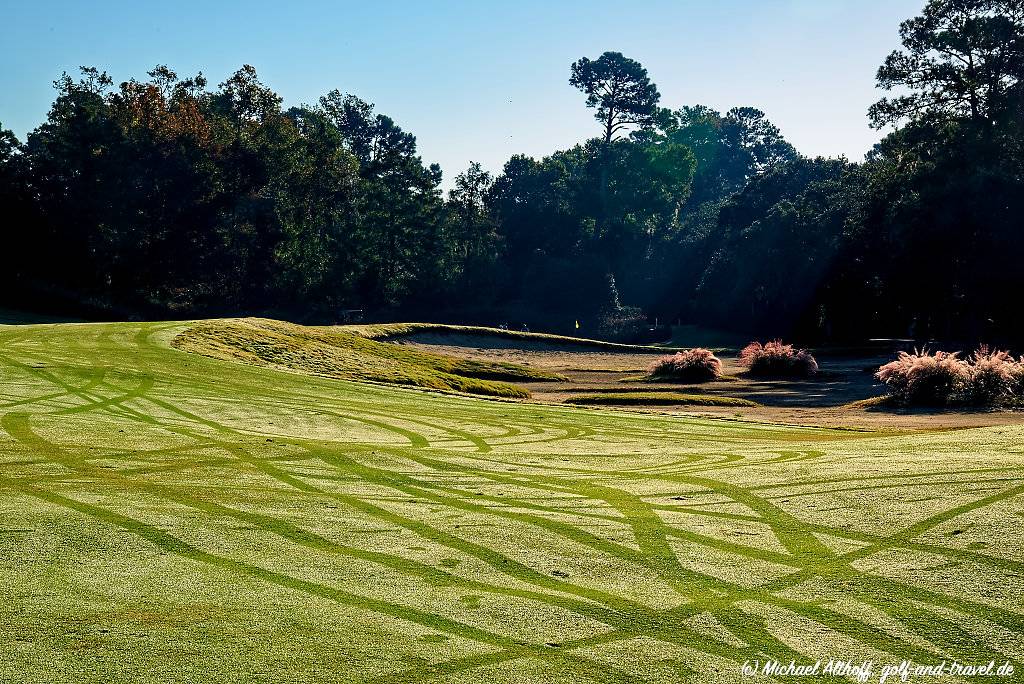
[12,66,442,311]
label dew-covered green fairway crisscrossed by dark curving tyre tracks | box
[0,324,1024,683]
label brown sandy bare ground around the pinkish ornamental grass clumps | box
[394,334,1024,431]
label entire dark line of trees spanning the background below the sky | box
[0,0,1024,342]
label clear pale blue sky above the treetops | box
[0,0,924,185]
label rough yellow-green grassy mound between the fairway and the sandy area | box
[172,318,561,398]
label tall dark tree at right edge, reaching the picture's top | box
[802,0,1024,343]
